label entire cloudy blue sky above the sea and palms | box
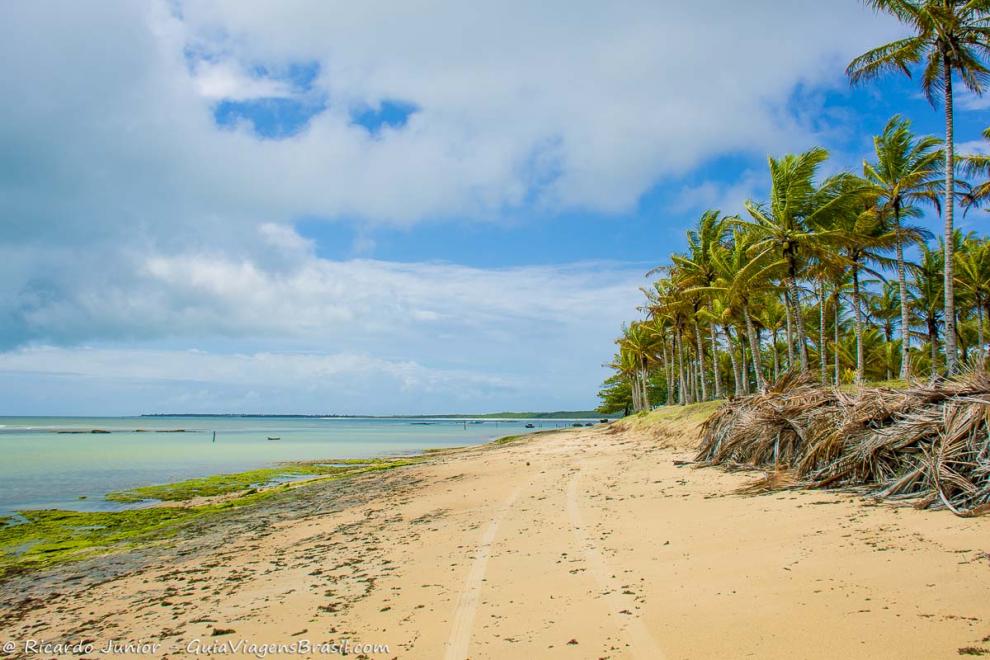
[0,0,990,415]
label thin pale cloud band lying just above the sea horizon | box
[0,346,528,415]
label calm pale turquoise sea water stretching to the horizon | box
[0,417,570,515]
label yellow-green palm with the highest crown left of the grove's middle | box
[737,147,861,371]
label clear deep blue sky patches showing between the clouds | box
[268,76,990,267]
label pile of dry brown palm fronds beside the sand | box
[697,372,990,516]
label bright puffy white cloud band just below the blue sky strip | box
[11,245,642,345]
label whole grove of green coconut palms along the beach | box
[599,0,990,413]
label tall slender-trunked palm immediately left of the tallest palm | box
[863,115,945,380]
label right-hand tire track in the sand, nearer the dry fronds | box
[567,472,664,660]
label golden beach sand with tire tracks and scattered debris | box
[0,410,990,658]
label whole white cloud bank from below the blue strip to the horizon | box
[0,242,643,414]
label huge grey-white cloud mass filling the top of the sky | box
[0,0,890,236]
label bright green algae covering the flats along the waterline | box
[0,457,422,578]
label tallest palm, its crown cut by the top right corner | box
[846,0,990,374]
